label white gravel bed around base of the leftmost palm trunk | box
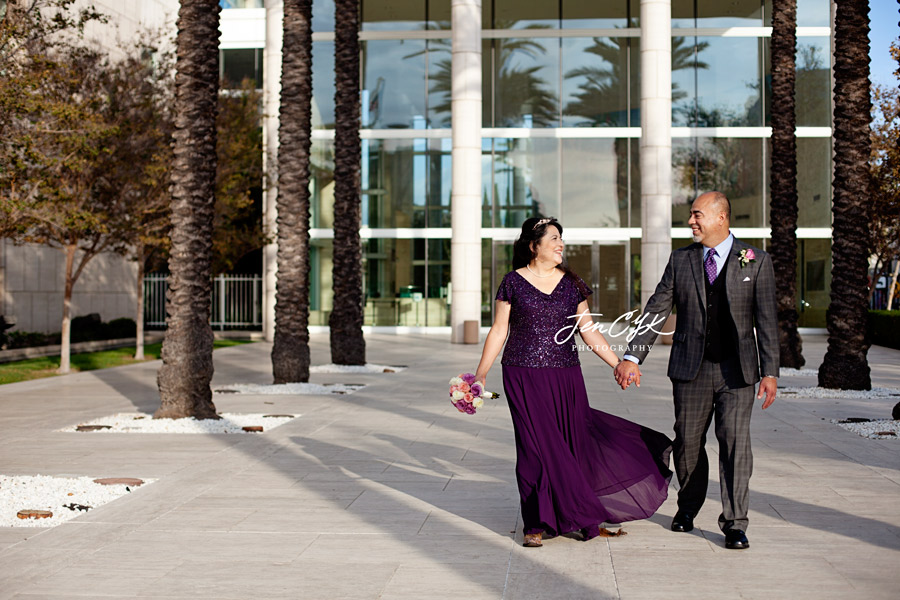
[57,413,300,435]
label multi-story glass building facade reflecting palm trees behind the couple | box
[222,0,831,328]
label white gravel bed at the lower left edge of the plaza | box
[0,475,156,527]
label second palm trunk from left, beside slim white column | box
[272,0,312,383]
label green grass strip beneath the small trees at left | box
[0,340,251,385]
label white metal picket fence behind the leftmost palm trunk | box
[144,273,262,330]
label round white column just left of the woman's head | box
[450,0,481,343]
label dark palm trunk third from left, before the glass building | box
[328,0,366,365]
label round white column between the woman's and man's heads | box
[640,0,672,306]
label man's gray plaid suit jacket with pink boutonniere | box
[626,238,779,385]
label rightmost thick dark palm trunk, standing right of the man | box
[819,0,872,390]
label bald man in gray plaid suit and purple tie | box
[615,192,779,549]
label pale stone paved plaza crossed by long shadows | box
[0,335,900,600]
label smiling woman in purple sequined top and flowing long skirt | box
[475,218,672,547]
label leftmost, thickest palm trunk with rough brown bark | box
[154,0,221,419]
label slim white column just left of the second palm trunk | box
[262,0,284,342]
